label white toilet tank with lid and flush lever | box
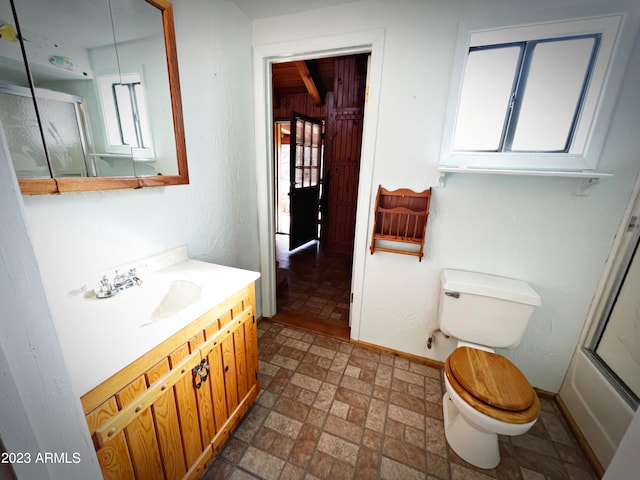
[439,269,541,348]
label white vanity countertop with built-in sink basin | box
[56,247,260,396]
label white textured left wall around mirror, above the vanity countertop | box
[24,0,259,395]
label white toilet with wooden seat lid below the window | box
[439,269,541,469]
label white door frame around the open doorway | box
[253,28,385,339]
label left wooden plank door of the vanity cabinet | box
[87,349,203,480]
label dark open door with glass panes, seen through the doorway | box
[289,112,322,250]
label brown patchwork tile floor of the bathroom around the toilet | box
[201,320,597,480]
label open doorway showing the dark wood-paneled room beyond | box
[272,53,369,338]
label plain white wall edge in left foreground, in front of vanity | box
[0,124,100,480]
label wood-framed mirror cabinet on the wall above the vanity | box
[0,0,188,194]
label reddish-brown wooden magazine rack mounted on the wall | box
[369,185,431,261]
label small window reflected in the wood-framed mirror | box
[98,73,153,158]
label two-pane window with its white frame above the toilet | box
[440,15,629,171]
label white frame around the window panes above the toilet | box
[439,8,637,173]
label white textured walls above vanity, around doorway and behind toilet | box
[15,0,640,398]
